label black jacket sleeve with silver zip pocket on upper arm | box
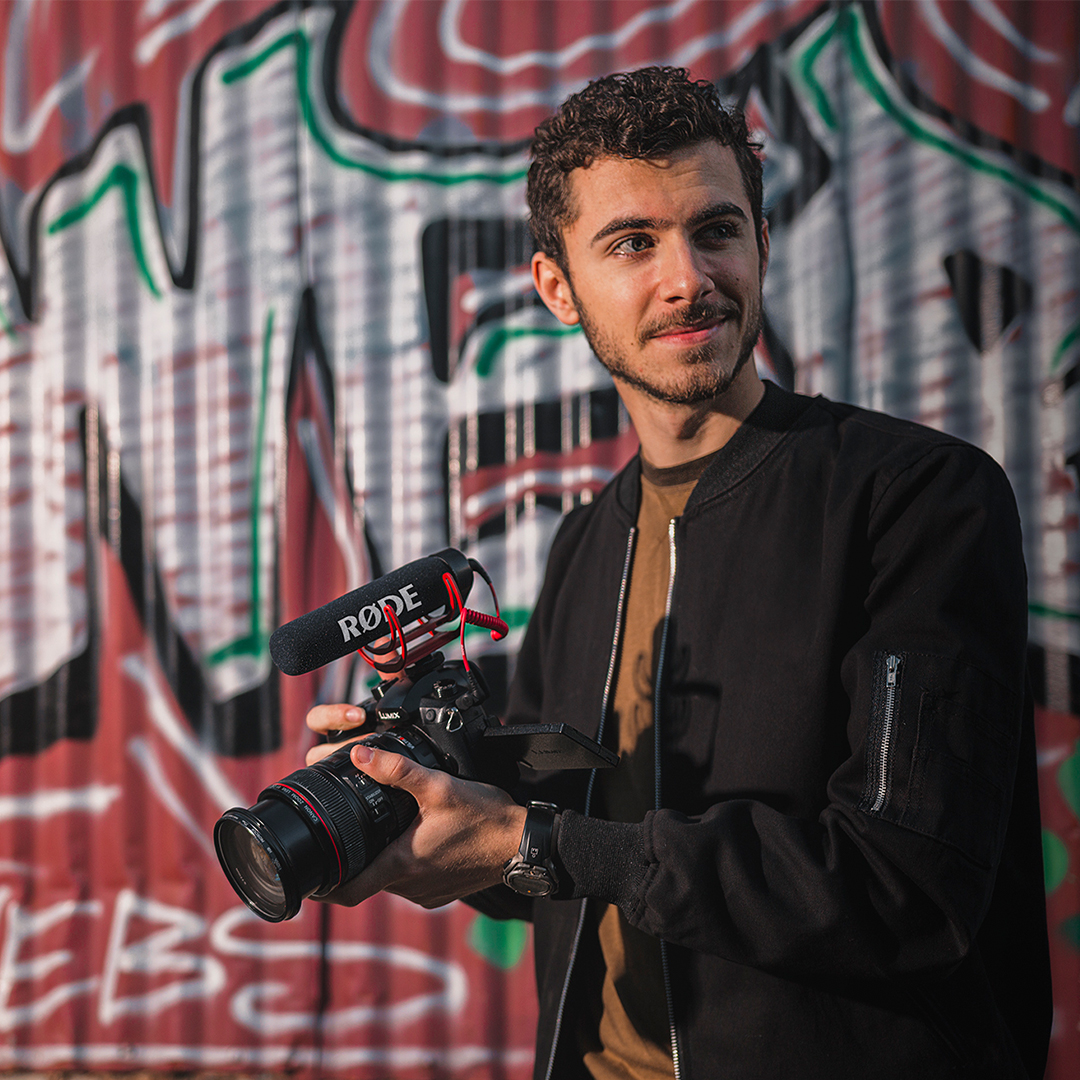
[558,445,1030,978]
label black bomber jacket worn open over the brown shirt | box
[478,384,1051,1080]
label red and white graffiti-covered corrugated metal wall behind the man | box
[0,0,1080,1080]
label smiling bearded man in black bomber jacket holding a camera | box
[309,68,1050,1080]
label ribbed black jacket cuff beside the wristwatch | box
[555,810,648,910]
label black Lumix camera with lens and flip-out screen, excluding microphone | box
[214,652,618,922]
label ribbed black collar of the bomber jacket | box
[615,380,811,524]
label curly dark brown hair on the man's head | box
[527,67,761,273]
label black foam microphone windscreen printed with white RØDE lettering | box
[270,548,473,675]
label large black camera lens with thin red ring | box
[214,727,438,922]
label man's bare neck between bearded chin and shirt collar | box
[616,361,765,469]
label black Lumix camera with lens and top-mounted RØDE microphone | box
[214,549,618,922]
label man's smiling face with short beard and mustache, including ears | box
[534,141,769,405]
